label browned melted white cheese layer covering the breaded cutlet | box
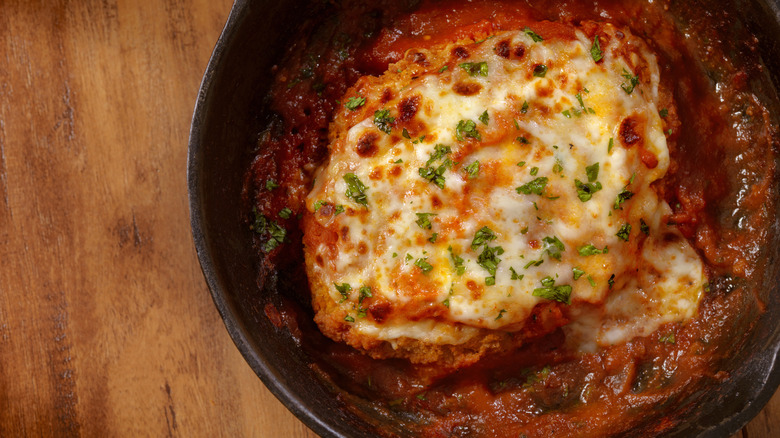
[307,26,706,350]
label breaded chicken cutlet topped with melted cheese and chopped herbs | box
[302,22,707,367]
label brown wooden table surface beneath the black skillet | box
[0,0,780,438]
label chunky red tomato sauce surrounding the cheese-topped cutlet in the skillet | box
[244,0,778,438]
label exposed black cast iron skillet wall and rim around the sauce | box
[187,0,780,437]
